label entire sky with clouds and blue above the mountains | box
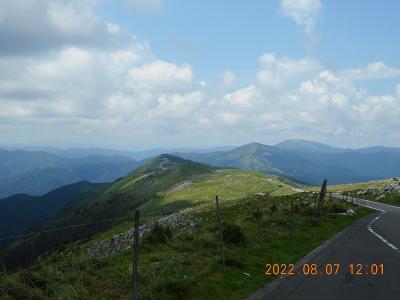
[0,0,400,149]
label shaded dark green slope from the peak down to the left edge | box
[0,155,214,267]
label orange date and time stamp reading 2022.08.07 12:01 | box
[265,263,384,276]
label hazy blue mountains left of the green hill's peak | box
[0,150,143,198]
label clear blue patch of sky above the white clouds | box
[98,0,400,88]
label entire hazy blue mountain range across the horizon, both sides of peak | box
[0,140,400,198]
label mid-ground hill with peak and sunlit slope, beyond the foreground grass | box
[0,154,298,266]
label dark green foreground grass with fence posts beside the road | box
[0,193,370,299]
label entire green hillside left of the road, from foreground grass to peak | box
[0,155,378,299]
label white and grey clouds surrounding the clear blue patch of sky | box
[0,0,400,147]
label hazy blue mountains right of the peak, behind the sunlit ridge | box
[175,140,400,185]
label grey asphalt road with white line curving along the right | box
[249,195,400,300]
